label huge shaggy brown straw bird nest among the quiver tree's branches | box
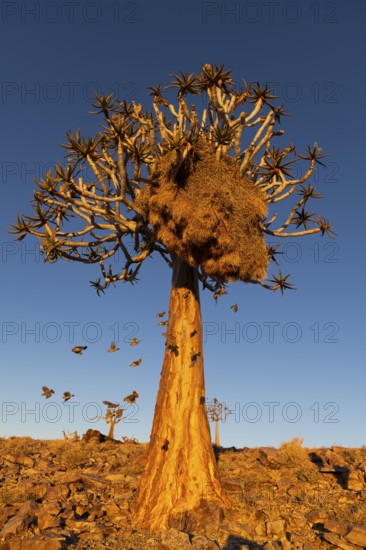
[139,138,268,282]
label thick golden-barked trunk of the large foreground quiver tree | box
[133,259,231,531]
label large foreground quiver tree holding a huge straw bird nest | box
[14,65,331,530]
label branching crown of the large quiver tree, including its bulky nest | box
[12,64,333,298]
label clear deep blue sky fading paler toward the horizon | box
[0,0,366,446]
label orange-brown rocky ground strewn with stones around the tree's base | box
[0,437,366,550]
